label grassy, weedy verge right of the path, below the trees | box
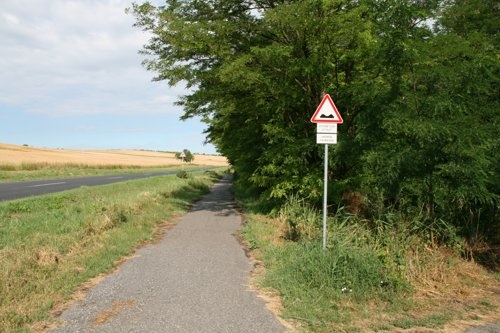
[242,198,500,332]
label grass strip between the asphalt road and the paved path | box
[0,172,225,332]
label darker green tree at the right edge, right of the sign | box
[363,0,500,241]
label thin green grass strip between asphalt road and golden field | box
[0,163,205,182]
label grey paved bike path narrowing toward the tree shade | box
[53,178,285,333]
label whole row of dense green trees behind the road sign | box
[129,0,500,249]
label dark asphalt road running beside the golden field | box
[0,167,215,201]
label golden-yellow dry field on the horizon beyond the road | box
[0,143,228,167]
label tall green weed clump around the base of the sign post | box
[265,197,410,301]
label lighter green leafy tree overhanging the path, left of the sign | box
[129,0,374,199]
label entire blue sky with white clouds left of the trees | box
[0,0,216,154]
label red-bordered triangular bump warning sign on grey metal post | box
[311,94,344,250]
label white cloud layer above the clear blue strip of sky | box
[0,0,183,116]
